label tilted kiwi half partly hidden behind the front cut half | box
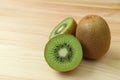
[49,17,77,39]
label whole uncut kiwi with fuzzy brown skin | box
[76,15,111,59]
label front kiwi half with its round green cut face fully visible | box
[44,34,83,72]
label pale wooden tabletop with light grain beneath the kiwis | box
[0,0,120,80]
